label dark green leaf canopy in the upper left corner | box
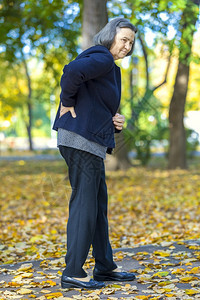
[0,0,80,62]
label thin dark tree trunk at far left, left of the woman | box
[23,59,33,151]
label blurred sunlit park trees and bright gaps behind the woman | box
[0,0,200,168]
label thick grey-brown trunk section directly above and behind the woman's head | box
[82,0,108,50]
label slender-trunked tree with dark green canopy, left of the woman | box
[0,0,79,150]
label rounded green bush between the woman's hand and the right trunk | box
[124,91,168,165]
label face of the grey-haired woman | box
[110,28,135,60]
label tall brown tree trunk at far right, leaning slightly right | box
[168,0,198,169]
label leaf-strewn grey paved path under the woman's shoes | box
[0,240,200,300]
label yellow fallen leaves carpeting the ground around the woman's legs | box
[0,161,200,300]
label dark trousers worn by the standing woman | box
[59,146,117,278]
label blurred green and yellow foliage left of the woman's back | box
[0,0,81,138]
